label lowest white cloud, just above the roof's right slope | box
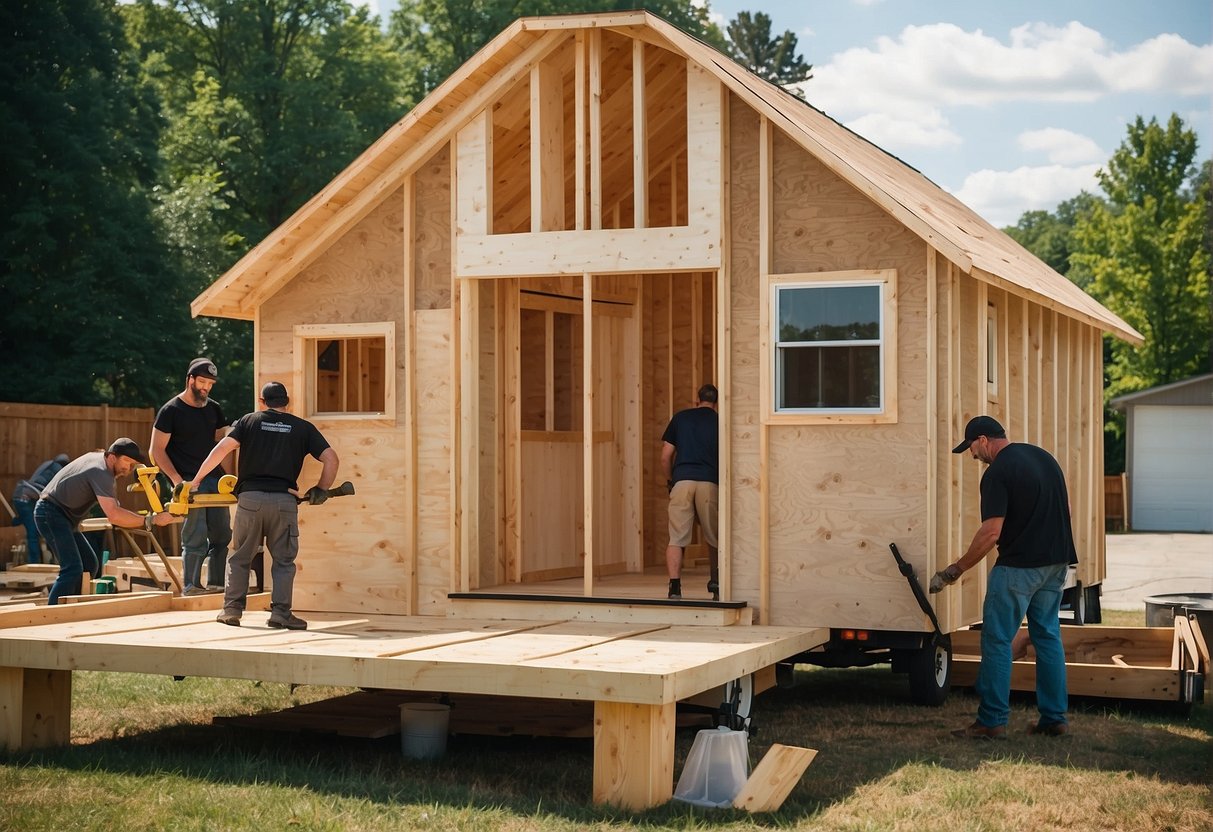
[953,165,1100,228]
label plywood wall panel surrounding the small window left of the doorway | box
[258,192,409,612]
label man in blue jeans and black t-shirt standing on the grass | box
[930,416,1078,740]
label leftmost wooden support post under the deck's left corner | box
[0,667,72,752]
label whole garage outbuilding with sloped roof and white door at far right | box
[1111,374,1213,531]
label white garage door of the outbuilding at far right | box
[1129,405,1213,531]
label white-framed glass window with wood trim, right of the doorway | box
[771,270,895,415]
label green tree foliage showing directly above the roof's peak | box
[389,0,725,104]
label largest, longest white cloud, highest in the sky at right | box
[808,22,1213,121]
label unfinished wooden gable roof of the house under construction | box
[192,11,1144,344]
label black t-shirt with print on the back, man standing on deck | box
[228,410,329,494]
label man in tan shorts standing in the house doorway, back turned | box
[661,384,721,600]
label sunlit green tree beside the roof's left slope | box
[124,0,406,404]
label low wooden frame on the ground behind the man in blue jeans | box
[951,625,1203,702]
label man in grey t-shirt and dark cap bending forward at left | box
[34,437,176,604]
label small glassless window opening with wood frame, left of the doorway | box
[295,323,395,418]
